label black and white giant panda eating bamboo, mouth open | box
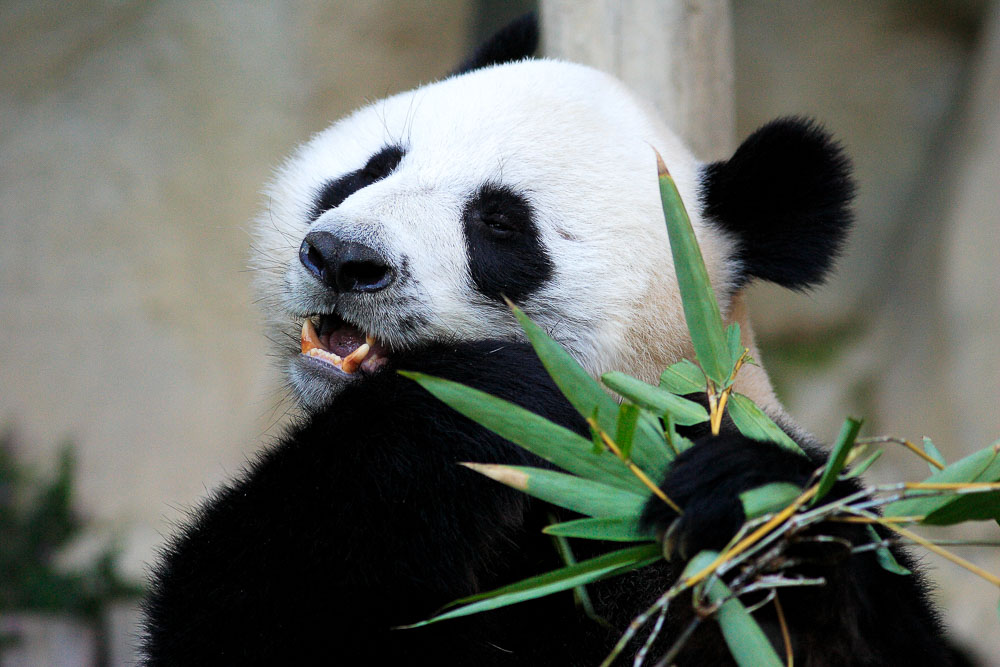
[143,18,953,667]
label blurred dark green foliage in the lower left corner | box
[0,432,141,618]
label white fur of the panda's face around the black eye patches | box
[254,60,748,404]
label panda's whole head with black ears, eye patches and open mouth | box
[253,15,852,408]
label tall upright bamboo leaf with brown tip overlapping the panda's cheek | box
[657,154,732,386]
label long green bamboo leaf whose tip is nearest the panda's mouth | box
[399,371,646,492]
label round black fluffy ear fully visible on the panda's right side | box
[701,118,854,289]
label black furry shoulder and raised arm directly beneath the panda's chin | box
[145,342,656,667]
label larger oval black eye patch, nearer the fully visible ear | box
[462,183,553,301]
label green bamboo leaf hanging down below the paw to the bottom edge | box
[681,551,783,667]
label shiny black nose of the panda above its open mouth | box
[299,232,393,292]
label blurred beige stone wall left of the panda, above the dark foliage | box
[0,0,470,576]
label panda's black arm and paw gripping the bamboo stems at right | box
[644,432,957,665]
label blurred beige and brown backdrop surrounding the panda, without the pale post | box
[0,0,1000,665]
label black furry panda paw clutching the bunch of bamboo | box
[642,434,817,562]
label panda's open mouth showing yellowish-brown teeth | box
[302,315,389,375]
